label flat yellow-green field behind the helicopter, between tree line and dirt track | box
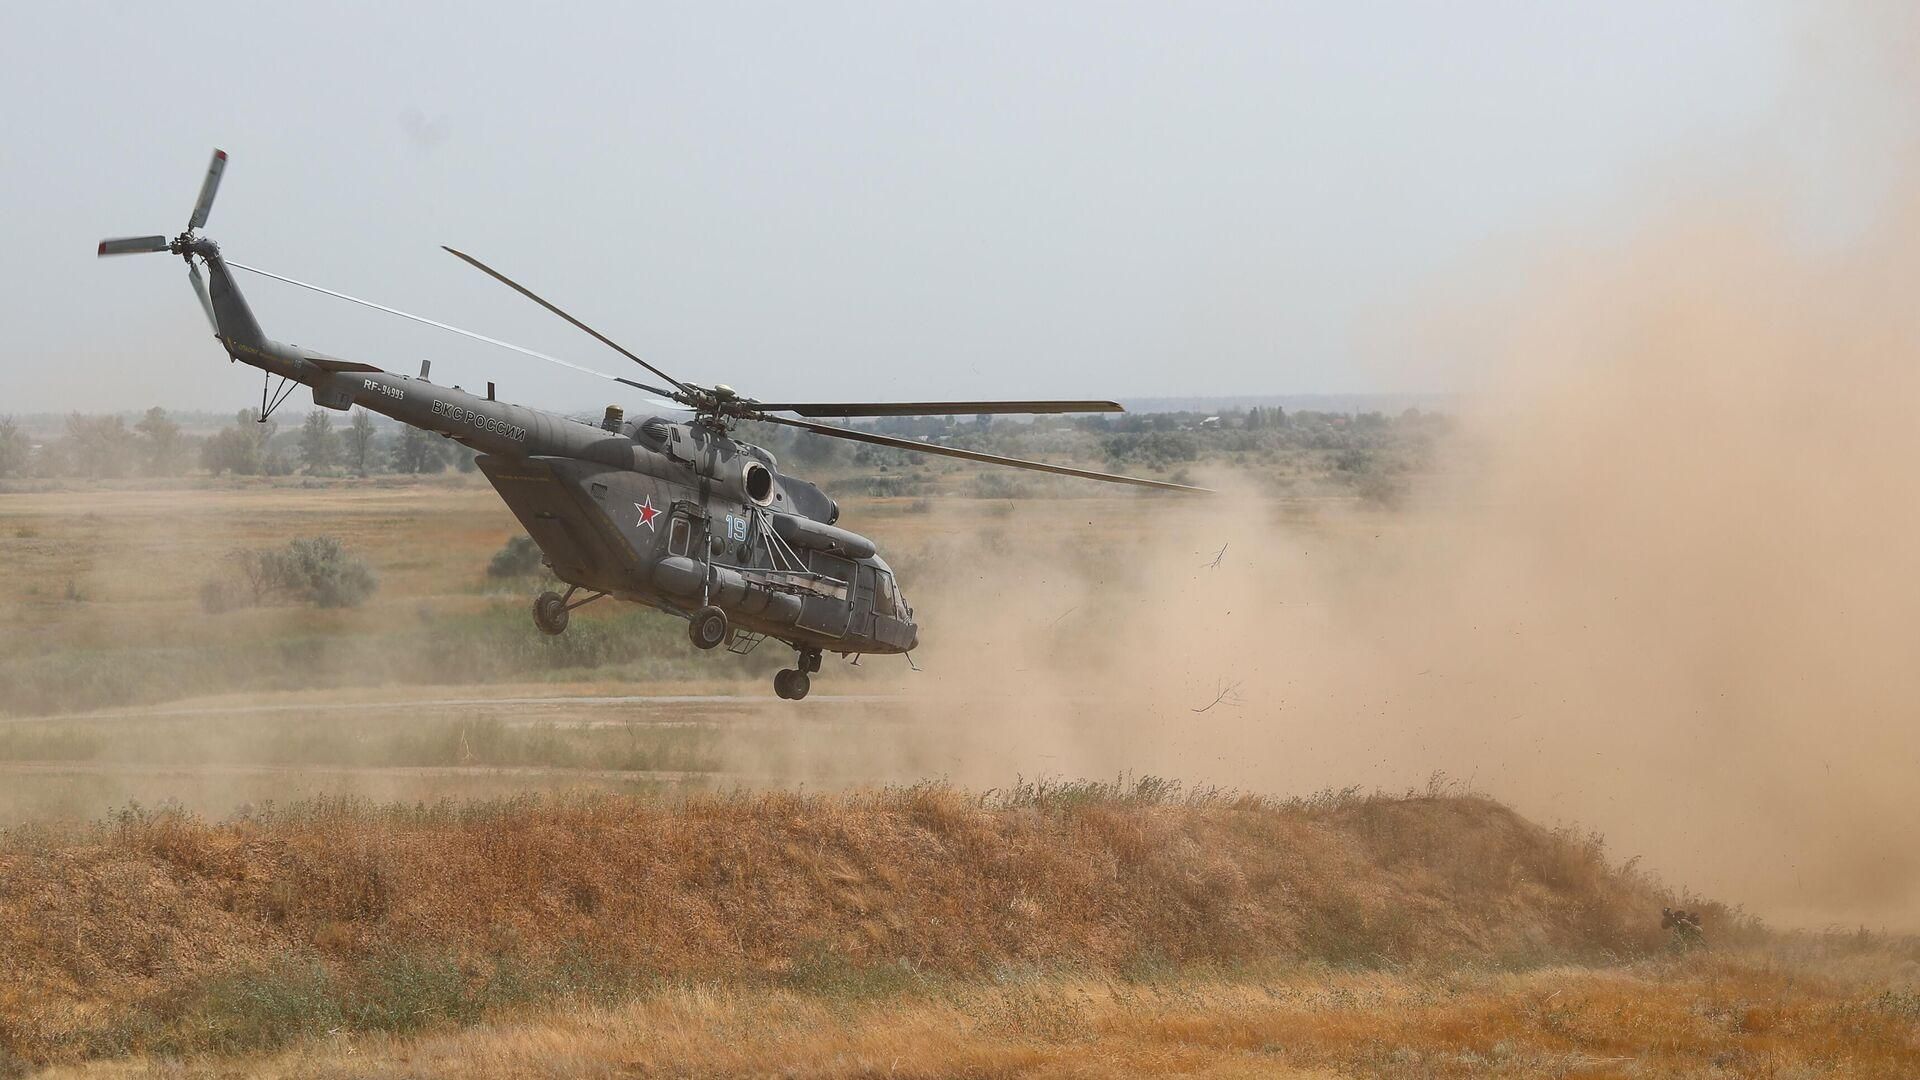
[0,465,1259,715]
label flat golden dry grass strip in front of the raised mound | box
[30,951,1920,1078]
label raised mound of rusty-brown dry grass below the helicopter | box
[0,782,1689,1063]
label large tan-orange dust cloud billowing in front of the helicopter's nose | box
[794,8,1920,930]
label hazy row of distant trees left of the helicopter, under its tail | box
[0,407,474,480]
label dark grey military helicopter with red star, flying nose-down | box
[98,150,1204,701]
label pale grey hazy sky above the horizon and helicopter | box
[0,0,1803,411]
